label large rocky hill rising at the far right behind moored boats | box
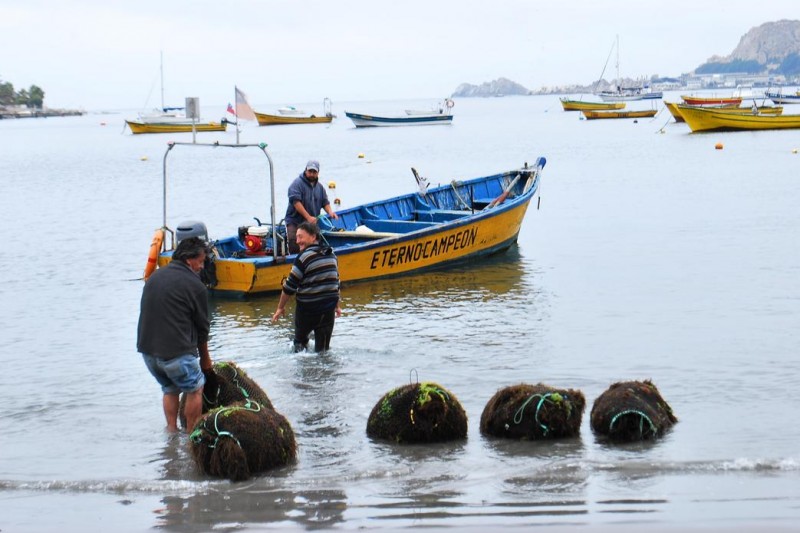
[694,20,800,77]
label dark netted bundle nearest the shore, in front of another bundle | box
[189,400,297,481]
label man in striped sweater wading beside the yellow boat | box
[272,222,342,352]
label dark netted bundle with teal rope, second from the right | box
[481,383,586,440]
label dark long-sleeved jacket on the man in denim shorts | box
[136,261,209,359]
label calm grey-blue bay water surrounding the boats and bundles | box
[0,94,800,532]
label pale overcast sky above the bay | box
[0,0,800,111]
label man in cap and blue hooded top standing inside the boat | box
[284,159,339,254]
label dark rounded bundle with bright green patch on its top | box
[367,382,467,444]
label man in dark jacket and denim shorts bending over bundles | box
[136,237,212,432]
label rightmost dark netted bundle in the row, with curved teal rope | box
[591,380,678,442]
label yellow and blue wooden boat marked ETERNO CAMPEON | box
[145,143,546,297]
